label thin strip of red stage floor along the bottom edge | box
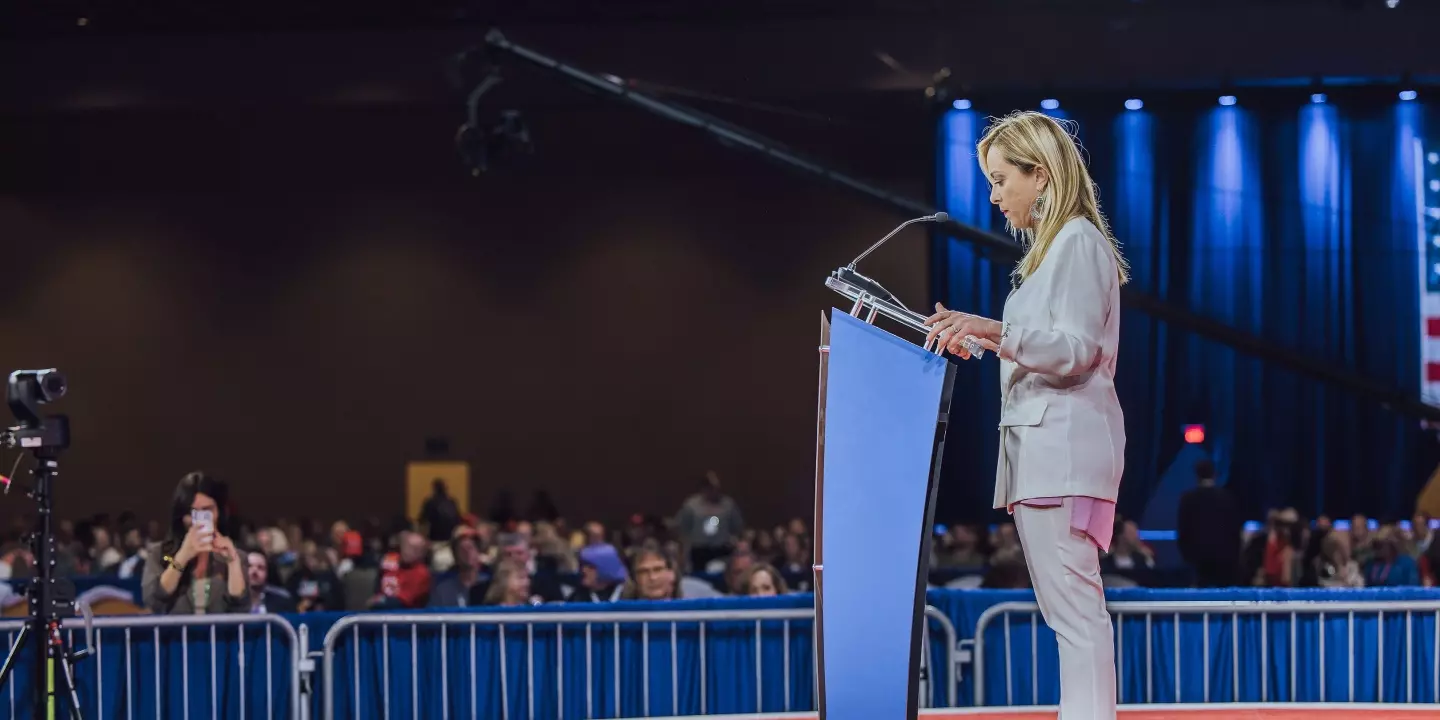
[655,703,1440,720]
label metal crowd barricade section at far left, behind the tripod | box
[0,615,302,720]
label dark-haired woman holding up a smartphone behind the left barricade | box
[141,472,249,615]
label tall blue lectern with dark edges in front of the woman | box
[815,270,955,720]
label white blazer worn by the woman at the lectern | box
[995,217,1125,508]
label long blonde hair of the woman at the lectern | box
[975,111,1130,285]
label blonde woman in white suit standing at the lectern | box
[930,112,1128,720]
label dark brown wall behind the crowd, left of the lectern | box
[0,99,930,520]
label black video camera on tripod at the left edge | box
[0,367,91,719]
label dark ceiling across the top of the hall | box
[0,0,1440,112]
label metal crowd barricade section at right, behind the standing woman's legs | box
[973,600,1440,706]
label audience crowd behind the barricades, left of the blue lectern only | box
[0,472,812,613]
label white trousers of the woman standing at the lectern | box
[1015,498,1115,720]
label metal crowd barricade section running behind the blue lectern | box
[321,608,958,720]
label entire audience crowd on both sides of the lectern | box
[0,462,1440,613]
